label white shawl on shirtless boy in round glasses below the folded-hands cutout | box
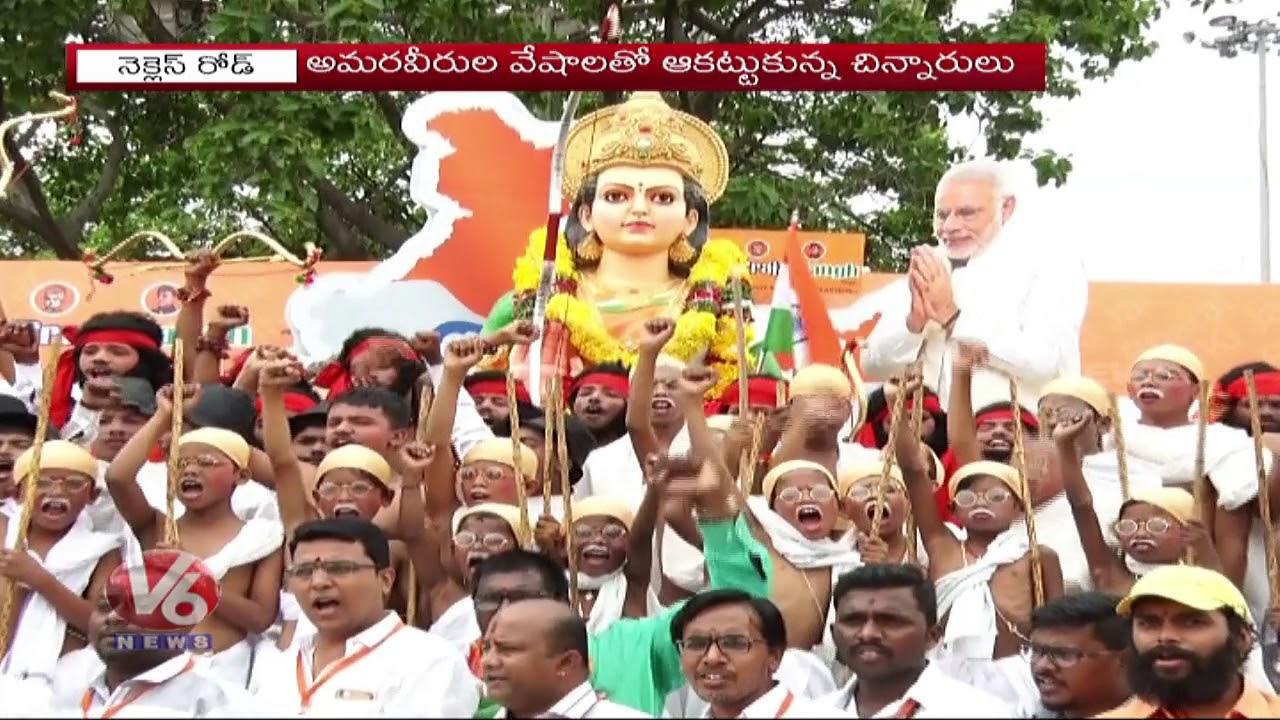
[937,521,1030,660]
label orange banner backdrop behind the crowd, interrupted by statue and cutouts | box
[0,257,1280,391]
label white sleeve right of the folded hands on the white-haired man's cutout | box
[957,245,1089,383]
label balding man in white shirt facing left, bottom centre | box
[483,600,649,719]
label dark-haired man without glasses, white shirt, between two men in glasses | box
[817,564,1014,717]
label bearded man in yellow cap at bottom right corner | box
[1097,565,1280,717]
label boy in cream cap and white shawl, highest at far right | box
[1124,345,1272,621]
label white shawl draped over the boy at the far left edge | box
[4,511,120,678]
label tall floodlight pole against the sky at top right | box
[1183,15,1280,283]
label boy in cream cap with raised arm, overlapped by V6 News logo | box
[106,417,284,687]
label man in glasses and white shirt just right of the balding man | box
[671,589,856,720]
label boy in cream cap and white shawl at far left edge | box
[0,441,120,683]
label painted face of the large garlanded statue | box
[579,165,698,255]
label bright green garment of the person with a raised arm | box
[476,515,773,717]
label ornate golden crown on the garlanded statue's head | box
[563,92,728,202]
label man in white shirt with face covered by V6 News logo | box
[51,593,259,719]
